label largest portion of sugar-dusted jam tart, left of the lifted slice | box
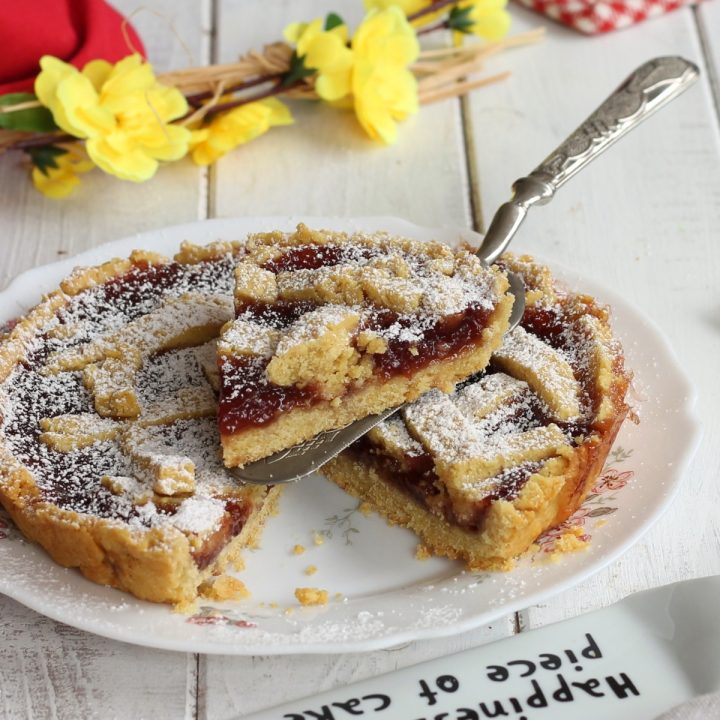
[0,243,277,603]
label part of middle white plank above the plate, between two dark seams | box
[214,0,469,225]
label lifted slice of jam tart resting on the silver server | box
[218,225,513,467]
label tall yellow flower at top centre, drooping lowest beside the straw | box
[352,6,420,143]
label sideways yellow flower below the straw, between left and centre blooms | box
[190,98,293,165]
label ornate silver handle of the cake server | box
[478,57,700,263]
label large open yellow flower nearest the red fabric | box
[35,54,190,182]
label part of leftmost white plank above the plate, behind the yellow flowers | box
[0,0,210,294]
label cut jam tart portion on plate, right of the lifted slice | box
[322,257,629,569]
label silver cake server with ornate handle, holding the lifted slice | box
[229,57,700,485]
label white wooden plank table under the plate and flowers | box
[0,0,720,720]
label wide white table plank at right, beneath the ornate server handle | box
[464,7,720,627]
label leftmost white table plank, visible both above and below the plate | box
[0,0,210,720]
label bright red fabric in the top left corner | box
[0,0,145,95]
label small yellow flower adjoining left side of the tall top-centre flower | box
[284,18,352,102]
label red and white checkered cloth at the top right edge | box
[518,0,691,35]
